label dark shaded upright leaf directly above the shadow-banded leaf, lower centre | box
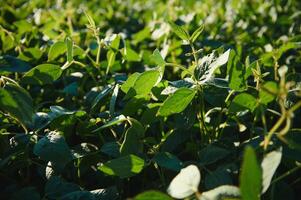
[120,119,145,155]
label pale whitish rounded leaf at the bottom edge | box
[167,165,201,199]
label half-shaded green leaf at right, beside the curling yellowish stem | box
[229,93,257,113]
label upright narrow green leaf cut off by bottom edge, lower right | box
[239,146,261,200]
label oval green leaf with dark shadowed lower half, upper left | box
[21,64,63,85]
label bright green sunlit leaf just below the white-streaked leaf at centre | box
[158,88,196,116]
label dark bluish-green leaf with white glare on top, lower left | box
[33,131,72,171]
